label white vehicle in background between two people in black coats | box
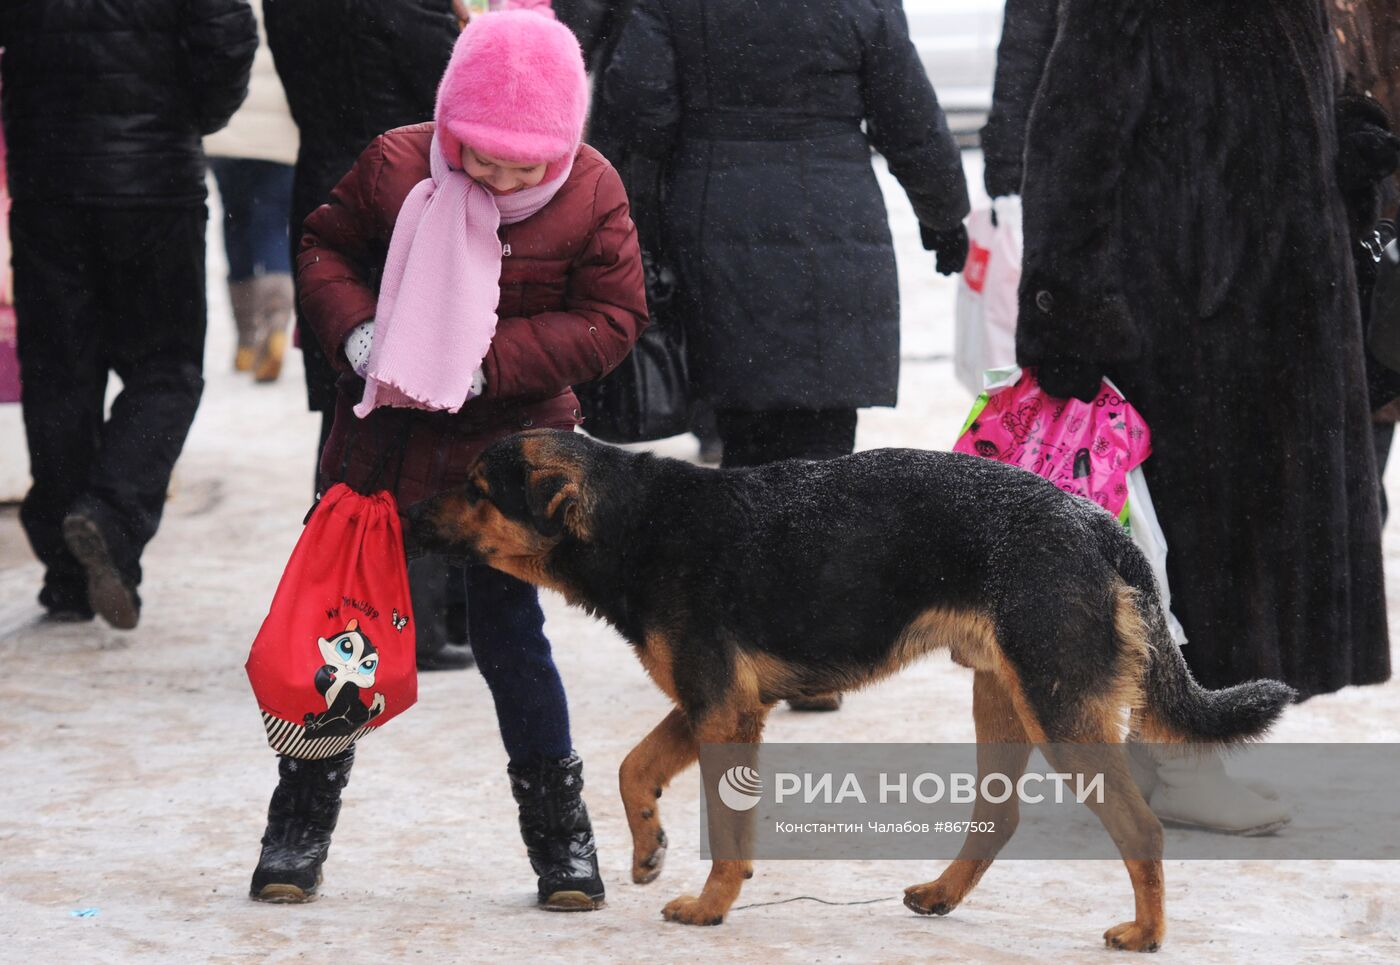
[904,0,1004,143]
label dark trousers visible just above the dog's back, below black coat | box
[714,409,855,469]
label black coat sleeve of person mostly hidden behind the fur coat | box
[981,0,1060,197]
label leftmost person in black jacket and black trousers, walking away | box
[0,0,258,629]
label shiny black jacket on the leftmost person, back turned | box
[0,0,258,207]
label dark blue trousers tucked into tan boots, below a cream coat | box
[209,157,294,282]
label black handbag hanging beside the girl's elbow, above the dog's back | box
[574,251,690,443]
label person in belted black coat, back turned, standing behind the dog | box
[603,0,969,466]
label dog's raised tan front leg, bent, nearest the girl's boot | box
[617,709,700,885]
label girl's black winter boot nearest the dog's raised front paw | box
[507,754,603,912]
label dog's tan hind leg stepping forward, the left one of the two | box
[904,671,1032,915]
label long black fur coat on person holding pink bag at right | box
[1016,0,1390,697]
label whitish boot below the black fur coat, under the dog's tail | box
[1138,745,1292,836]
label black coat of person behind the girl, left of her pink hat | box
[263,0,458,456]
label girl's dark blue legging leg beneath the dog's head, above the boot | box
[466,566,574,766]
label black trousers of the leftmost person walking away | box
[10,203,207,606]
